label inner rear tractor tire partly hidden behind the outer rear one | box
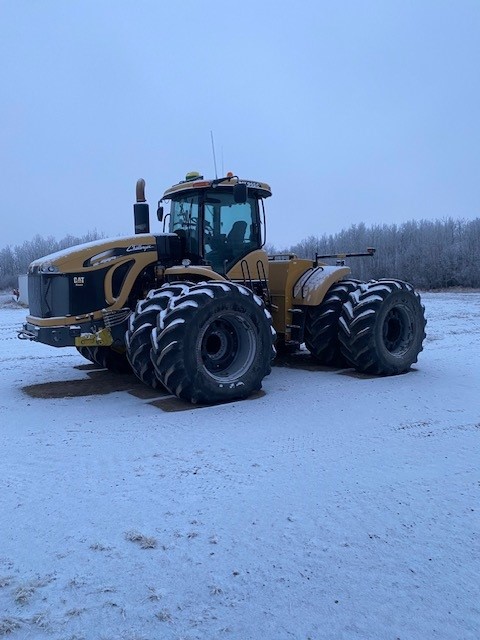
[305,279,360,367]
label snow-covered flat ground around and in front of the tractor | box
[0,293,480,640]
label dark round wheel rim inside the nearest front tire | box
[199,313,257,383]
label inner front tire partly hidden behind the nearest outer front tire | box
[125,282,190,389]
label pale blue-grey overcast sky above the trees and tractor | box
[0,0,480,249]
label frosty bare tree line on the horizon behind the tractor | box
[0,218,480,289]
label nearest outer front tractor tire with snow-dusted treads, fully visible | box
[152,281,275,404]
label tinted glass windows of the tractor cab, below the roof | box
[170,189,261,273]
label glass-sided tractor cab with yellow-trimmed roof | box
[160,172,271,274]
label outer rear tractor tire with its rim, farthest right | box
[339,279,426,376]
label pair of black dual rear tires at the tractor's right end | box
[305,279,426,375]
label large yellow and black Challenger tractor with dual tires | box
[19,172,426,403]
